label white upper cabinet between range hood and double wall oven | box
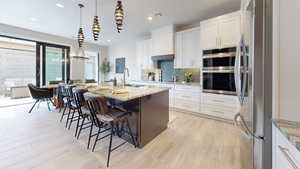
[175,27,202,68]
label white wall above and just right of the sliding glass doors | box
[0,24,108,80]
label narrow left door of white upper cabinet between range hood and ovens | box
[174,32,182,68]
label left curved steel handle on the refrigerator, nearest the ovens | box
[234,41,242,104]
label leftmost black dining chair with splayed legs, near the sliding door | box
[28,83,54,113]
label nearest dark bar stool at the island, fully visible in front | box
[84,93,136,167]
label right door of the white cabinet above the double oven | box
[219,15,241,48]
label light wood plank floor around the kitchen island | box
[0,105,240,169]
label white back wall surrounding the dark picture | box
[107,40,140,80]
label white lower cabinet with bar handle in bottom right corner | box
[273,125,300,169]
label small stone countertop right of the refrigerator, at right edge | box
[273,119,300,151]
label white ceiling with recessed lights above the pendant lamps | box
[0,0,240,45]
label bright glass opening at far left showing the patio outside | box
[0,37,36,99]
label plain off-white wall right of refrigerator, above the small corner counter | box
[273,0,300,122]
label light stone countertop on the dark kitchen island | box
[80,86,169,102]
